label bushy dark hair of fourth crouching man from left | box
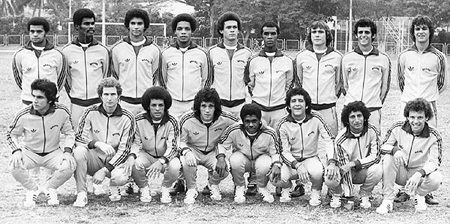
[194,88,222,120]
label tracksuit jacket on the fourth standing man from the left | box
[161,42,212,101]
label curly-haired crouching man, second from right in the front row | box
[324,101,383,209]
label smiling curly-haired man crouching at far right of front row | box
[376,98,443,214]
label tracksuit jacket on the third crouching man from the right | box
[276,111,336,169]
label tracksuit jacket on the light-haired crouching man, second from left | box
[75,104,136,171]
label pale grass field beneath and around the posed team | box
[0,49,450,224]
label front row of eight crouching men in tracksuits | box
[7,78,442,213]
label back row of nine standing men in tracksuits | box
[8,9,446,214]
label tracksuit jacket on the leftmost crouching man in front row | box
[6,103,75,155]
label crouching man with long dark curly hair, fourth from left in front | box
[180,88,238,204]
